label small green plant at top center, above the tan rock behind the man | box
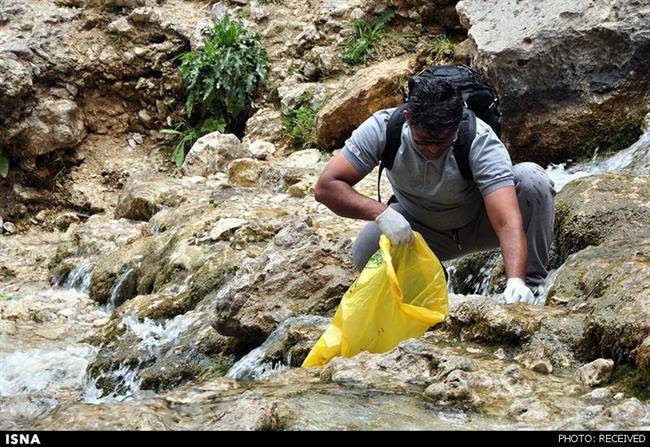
[343,8,395,65]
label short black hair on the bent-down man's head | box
[407,77,463,135]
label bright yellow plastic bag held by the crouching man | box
[302,232,447,367]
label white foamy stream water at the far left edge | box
[0,345,96,397]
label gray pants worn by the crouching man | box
[352,163,555,286]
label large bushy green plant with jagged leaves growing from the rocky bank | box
[175,14,270,128]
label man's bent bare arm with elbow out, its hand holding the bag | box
[314,152,387,220]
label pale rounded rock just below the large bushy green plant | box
[183,132,248,177]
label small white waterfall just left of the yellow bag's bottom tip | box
[226,315,330,380]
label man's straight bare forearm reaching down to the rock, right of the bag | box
[484,186,528,279]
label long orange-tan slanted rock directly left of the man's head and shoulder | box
[315,57,413,149]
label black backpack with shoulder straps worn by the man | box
[377,65,501,202]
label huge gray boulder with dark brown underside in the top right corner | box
[457,0,650,162]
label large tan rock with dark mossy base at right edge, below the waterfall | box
[547,230,650,363]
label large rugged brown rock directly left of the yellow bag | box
[214,221,354,347]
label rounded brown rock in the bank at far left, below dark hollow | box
[22,99,86,157]
